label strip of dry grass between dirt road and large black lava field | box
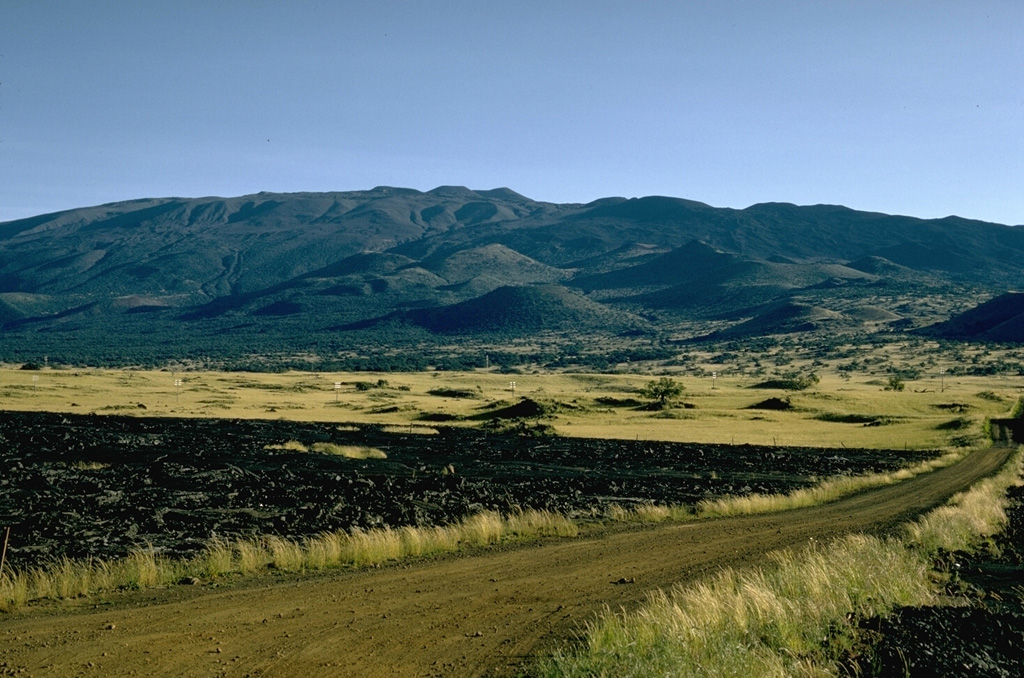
[0,440,1007,610]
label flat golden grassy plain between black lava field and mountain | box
[0,360,1024,449]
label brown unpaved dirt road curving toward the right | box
[0,448,1009,677]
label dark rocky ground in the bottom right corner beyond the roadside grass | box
[849,488,1024,678]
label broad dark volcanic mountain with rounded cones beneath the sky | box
[0,186,1024,365]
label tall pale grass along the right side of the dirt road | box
[536,450,1022,678]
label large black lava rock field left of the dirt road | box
[0,412,922,567]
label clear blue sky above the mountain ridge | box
[0,0,1024,224]
